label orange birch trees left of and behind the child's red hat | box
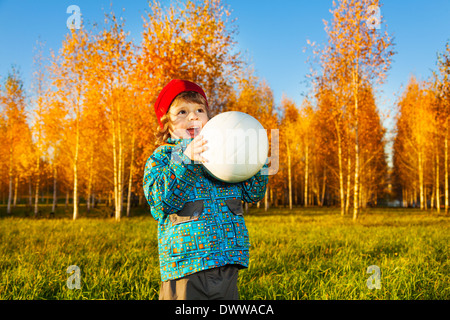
[0,0,244,220]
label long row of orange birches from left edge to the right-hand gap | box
[0,0,444,220]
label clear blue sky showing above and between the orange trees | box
[0,0,450,134]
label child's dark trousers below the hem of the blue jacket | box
[159,264,239,300]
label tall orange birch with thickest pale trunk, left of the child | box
[85,13,133,221]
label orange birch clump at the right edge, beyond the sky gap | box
[394,43,450,214]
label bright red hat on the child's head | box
[155,79,208,129]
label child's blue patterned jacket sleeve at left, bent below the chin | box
[144,146,195,220]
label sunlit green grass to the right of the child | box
[241,209,450,299]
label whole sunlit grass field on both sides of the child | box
[0,208,450,300]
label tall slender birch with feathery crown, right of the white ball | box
[322,0,394,220]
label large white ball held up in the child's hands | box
[200,111,269,183]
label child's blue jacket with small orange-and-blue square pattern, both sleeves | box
[144,139,268,281]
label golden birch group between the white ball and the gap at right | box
[281,0,394,219]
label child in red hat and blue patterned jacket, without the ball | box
[144,80,268,300]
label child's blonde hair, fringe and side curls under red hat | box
[155,91,210,146]
